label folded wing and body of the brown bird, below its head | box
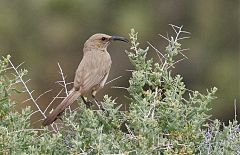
[74,52,111,93]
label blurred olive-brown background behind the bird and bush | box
[0,0,240,122]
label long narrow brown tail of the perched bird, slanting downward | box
[42,90,81,126]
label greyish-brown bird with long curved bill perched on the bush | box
[43,33,128,126]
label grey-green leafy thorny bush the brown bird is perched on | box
[0,25,240,154]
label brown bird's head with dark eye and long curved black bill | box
[84,33,128,50]
